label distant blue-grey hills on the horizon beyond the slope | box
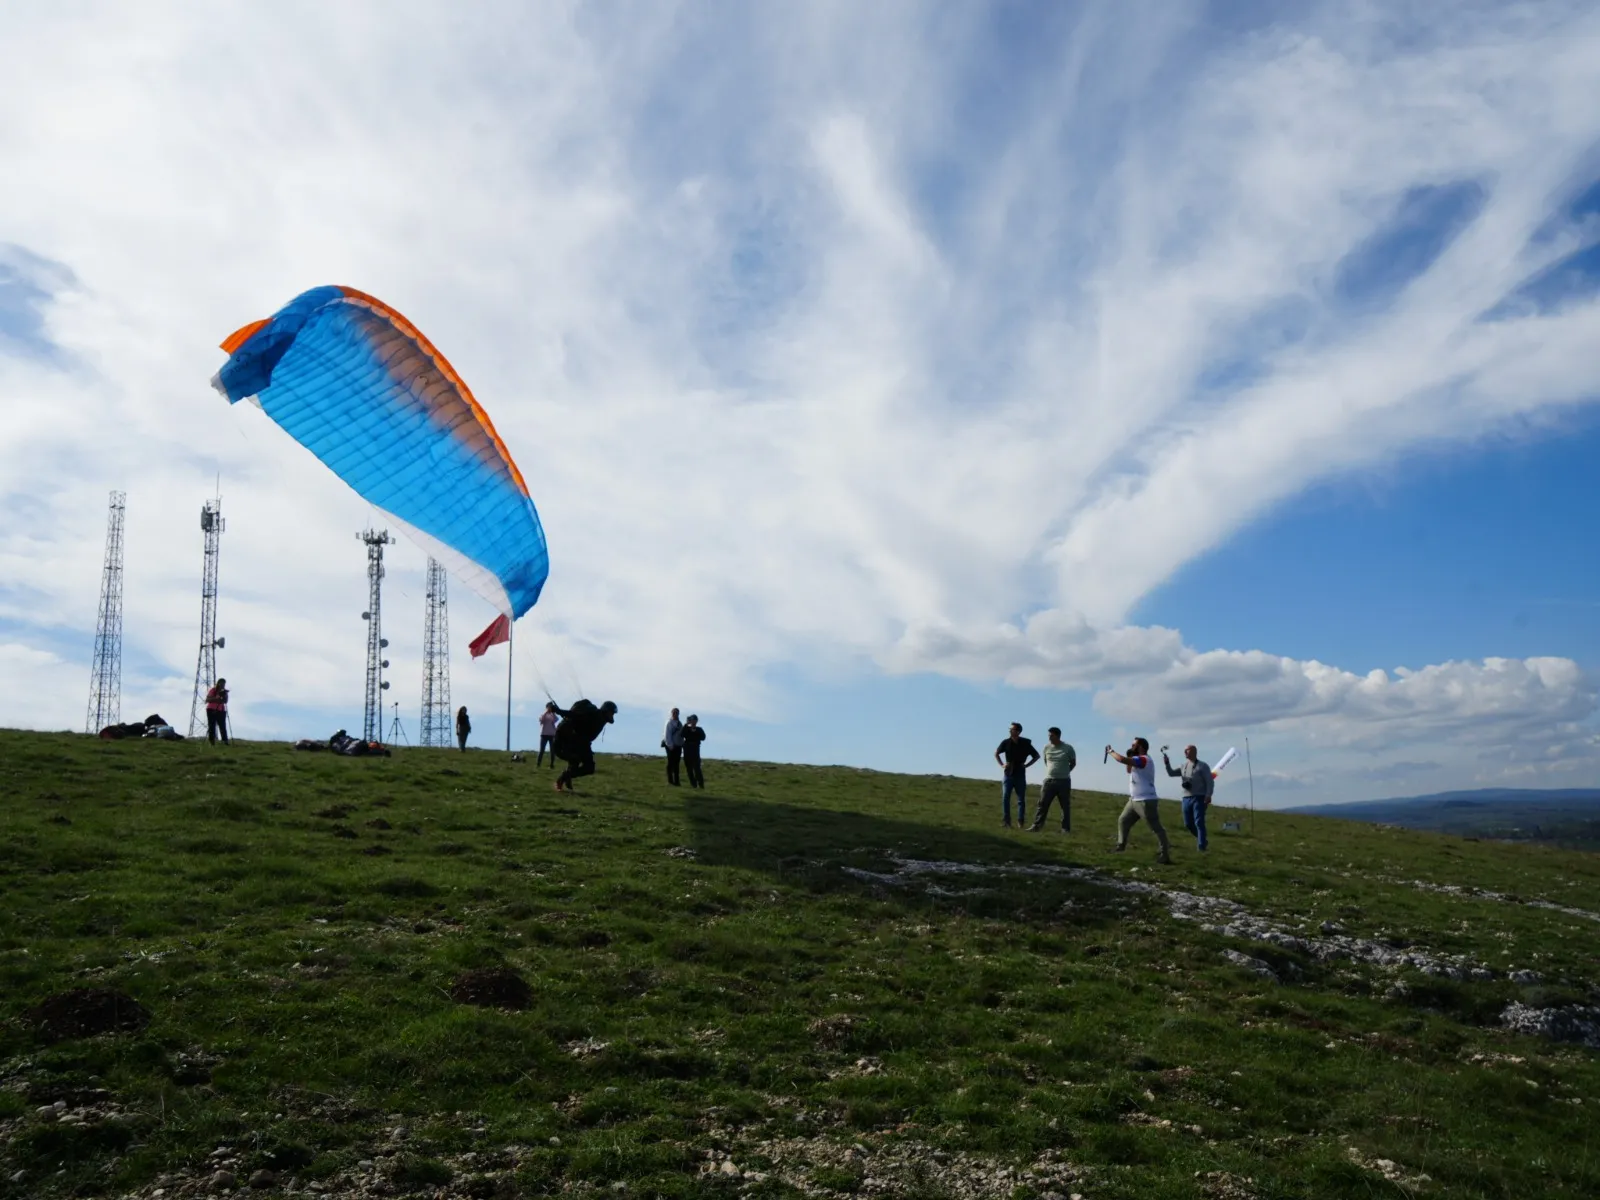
[1282,787,1600,850]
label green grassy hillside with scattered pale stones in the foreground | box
[0,733,1600,1200]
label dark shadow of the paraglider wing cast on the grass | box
[685,795,1126,925]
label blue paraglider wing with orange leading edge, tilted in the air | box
[211,286,550,619]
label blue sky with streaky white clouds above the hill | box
[0,0,1600,806]
